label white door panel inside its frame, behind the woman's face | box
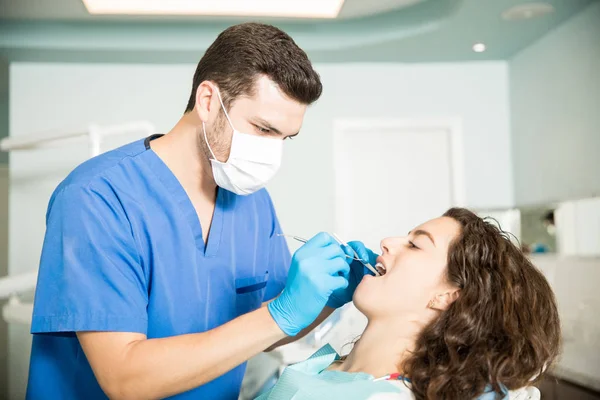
[334,122,455,250]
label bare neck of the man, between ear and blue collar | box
[151,112,217,198]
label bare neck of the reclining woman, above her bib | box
[337,315,428,378]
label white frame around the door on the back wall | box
[332,117,466,234]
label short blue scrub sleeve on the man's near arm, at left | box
[31,182,148,334]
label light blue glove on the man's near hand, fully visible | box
[268,233,350,336]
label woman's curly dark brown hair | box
[402,208,561,400]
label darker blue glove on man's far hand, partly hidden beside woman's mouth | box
[327,242,377,308]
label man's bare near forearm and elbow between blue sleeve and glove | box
[77,307,286,399]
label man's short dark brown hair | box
[185,23,323,112]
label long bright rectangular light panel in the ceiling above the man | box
[83,0,344,18]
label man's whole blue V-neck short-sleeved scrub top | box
[27,135,290,400]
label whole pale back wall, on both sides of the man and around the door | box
[9,62,513,398]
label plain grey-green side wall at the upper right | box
[510,2,600,205]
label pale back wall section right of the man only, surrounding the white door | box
[282,62,513,240]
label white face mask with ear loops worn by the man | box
[202,91,283,195]
